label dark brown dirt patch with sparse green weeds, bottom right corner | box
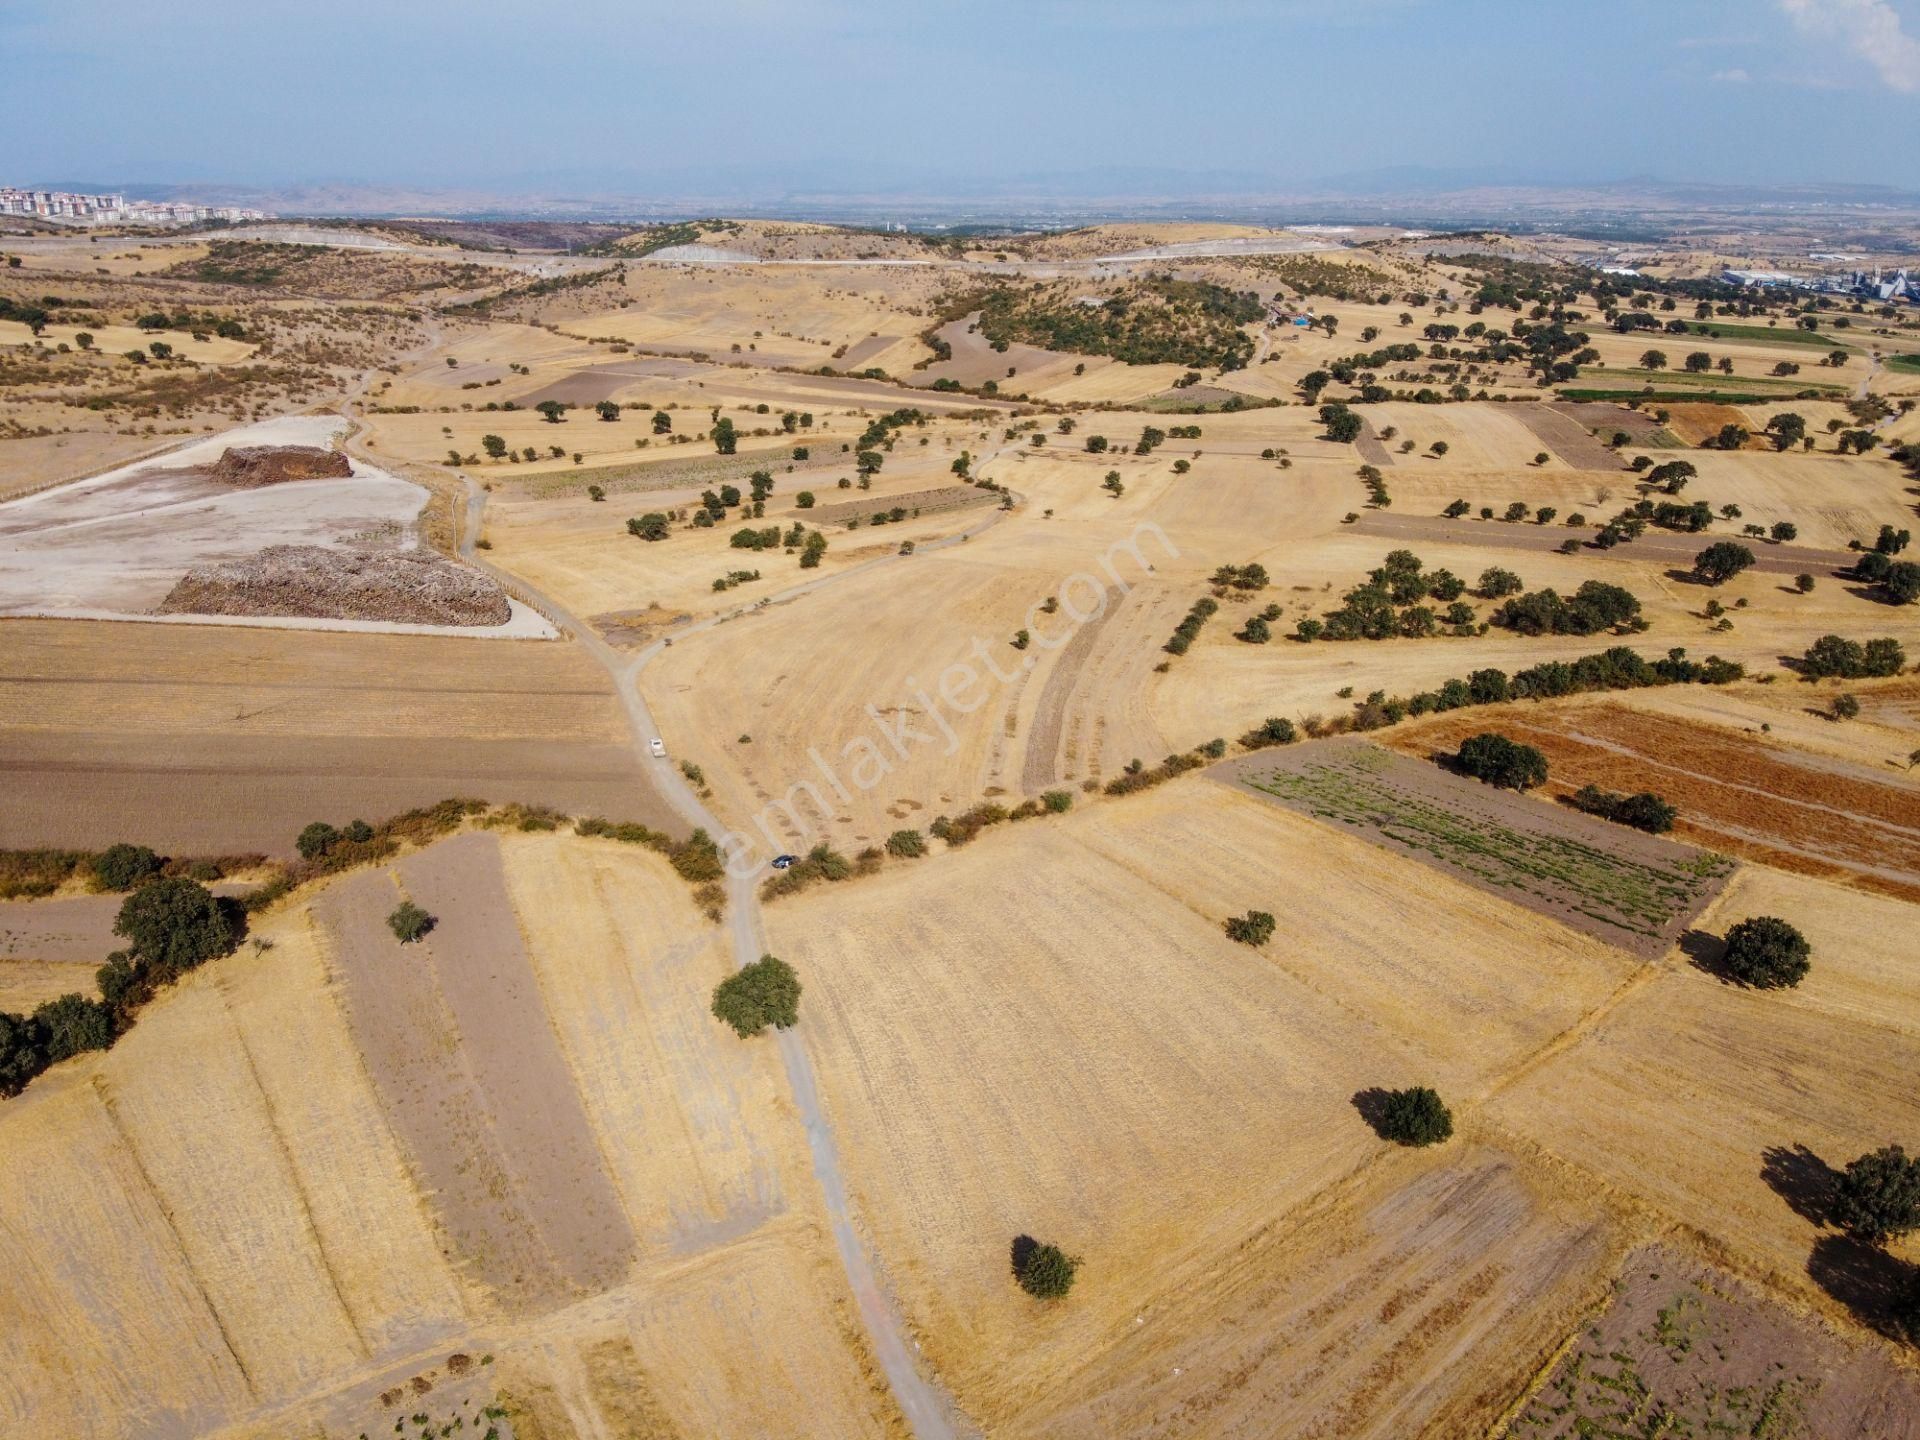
[1507,1246,1920,1440]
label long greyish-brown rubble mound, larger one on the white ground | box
[159,545,511,626]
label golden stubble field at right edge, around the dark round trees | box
[1484,917,1920,1321]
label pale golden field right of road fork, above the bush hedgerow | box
[641,411,1357,847]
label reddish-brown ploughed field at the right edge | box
[1388,701,1920,900]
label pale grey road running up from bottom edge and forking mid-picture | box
[459,474,975,1440]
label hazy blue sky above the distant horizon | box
[0,0,1920,200]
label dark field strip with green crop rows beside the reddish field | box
[1212,739,1734,958]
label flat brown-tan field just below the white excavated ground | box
[0,620,676,854]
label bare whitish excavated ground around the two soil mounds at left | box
[0,415,557,639]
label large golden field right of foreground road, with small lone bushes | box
[770,781,1630,1434]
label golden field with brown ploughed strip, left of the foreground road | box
[0,833,899,1436]
